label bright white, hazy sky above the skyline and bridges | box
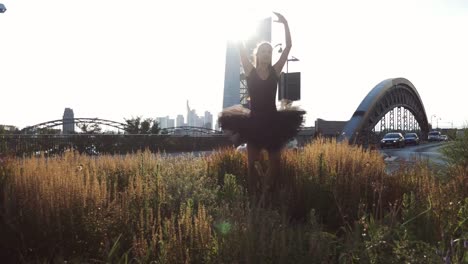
[0,0,468,128]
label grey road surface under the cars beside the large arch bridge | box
[380,142,447,171]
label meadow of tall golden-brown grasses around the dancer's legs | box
[0,139,468,263]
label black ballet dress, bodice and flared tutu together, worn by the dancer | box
[218,67,305,151]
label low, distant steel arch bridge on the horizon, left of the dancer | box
[21,118,127,134]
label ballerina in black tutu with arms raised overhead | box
[218,13,305,200]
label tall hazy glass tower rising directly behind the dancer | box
[223,17,271,108]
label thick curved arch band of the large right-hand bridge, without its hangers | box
[339,78,429,145]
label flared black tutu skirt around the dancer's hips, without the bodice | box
[218,105,305,151]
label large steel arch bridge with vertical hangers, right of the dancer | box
[338,78,429,145]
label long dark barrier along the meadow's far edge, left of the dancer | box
[0,134,232,155]
